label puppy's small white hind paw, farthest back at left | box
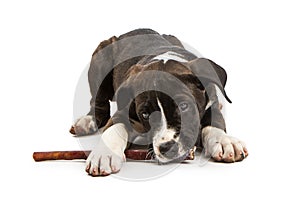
[73,115,97,135]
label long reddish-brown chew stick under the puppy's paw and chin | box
[33,149,195,161]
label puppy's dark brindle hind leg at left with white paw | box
[70,37,116,136]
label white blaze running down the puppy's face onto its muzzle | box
[153,98,179,161]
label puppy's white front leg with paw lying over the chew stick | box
[86,123,128,176]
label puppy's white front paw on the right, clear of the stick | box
[202,126,248,162]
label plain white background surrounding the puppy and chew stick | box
[0,0,300,214]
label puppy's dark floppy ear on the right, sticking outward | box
[188,58,231,103]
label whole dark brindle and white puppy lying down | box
[72,29,248,176]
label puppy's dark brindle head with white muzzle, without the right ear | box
[117,59,230,163]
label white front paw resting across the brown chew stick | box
[86,142,126,176]
